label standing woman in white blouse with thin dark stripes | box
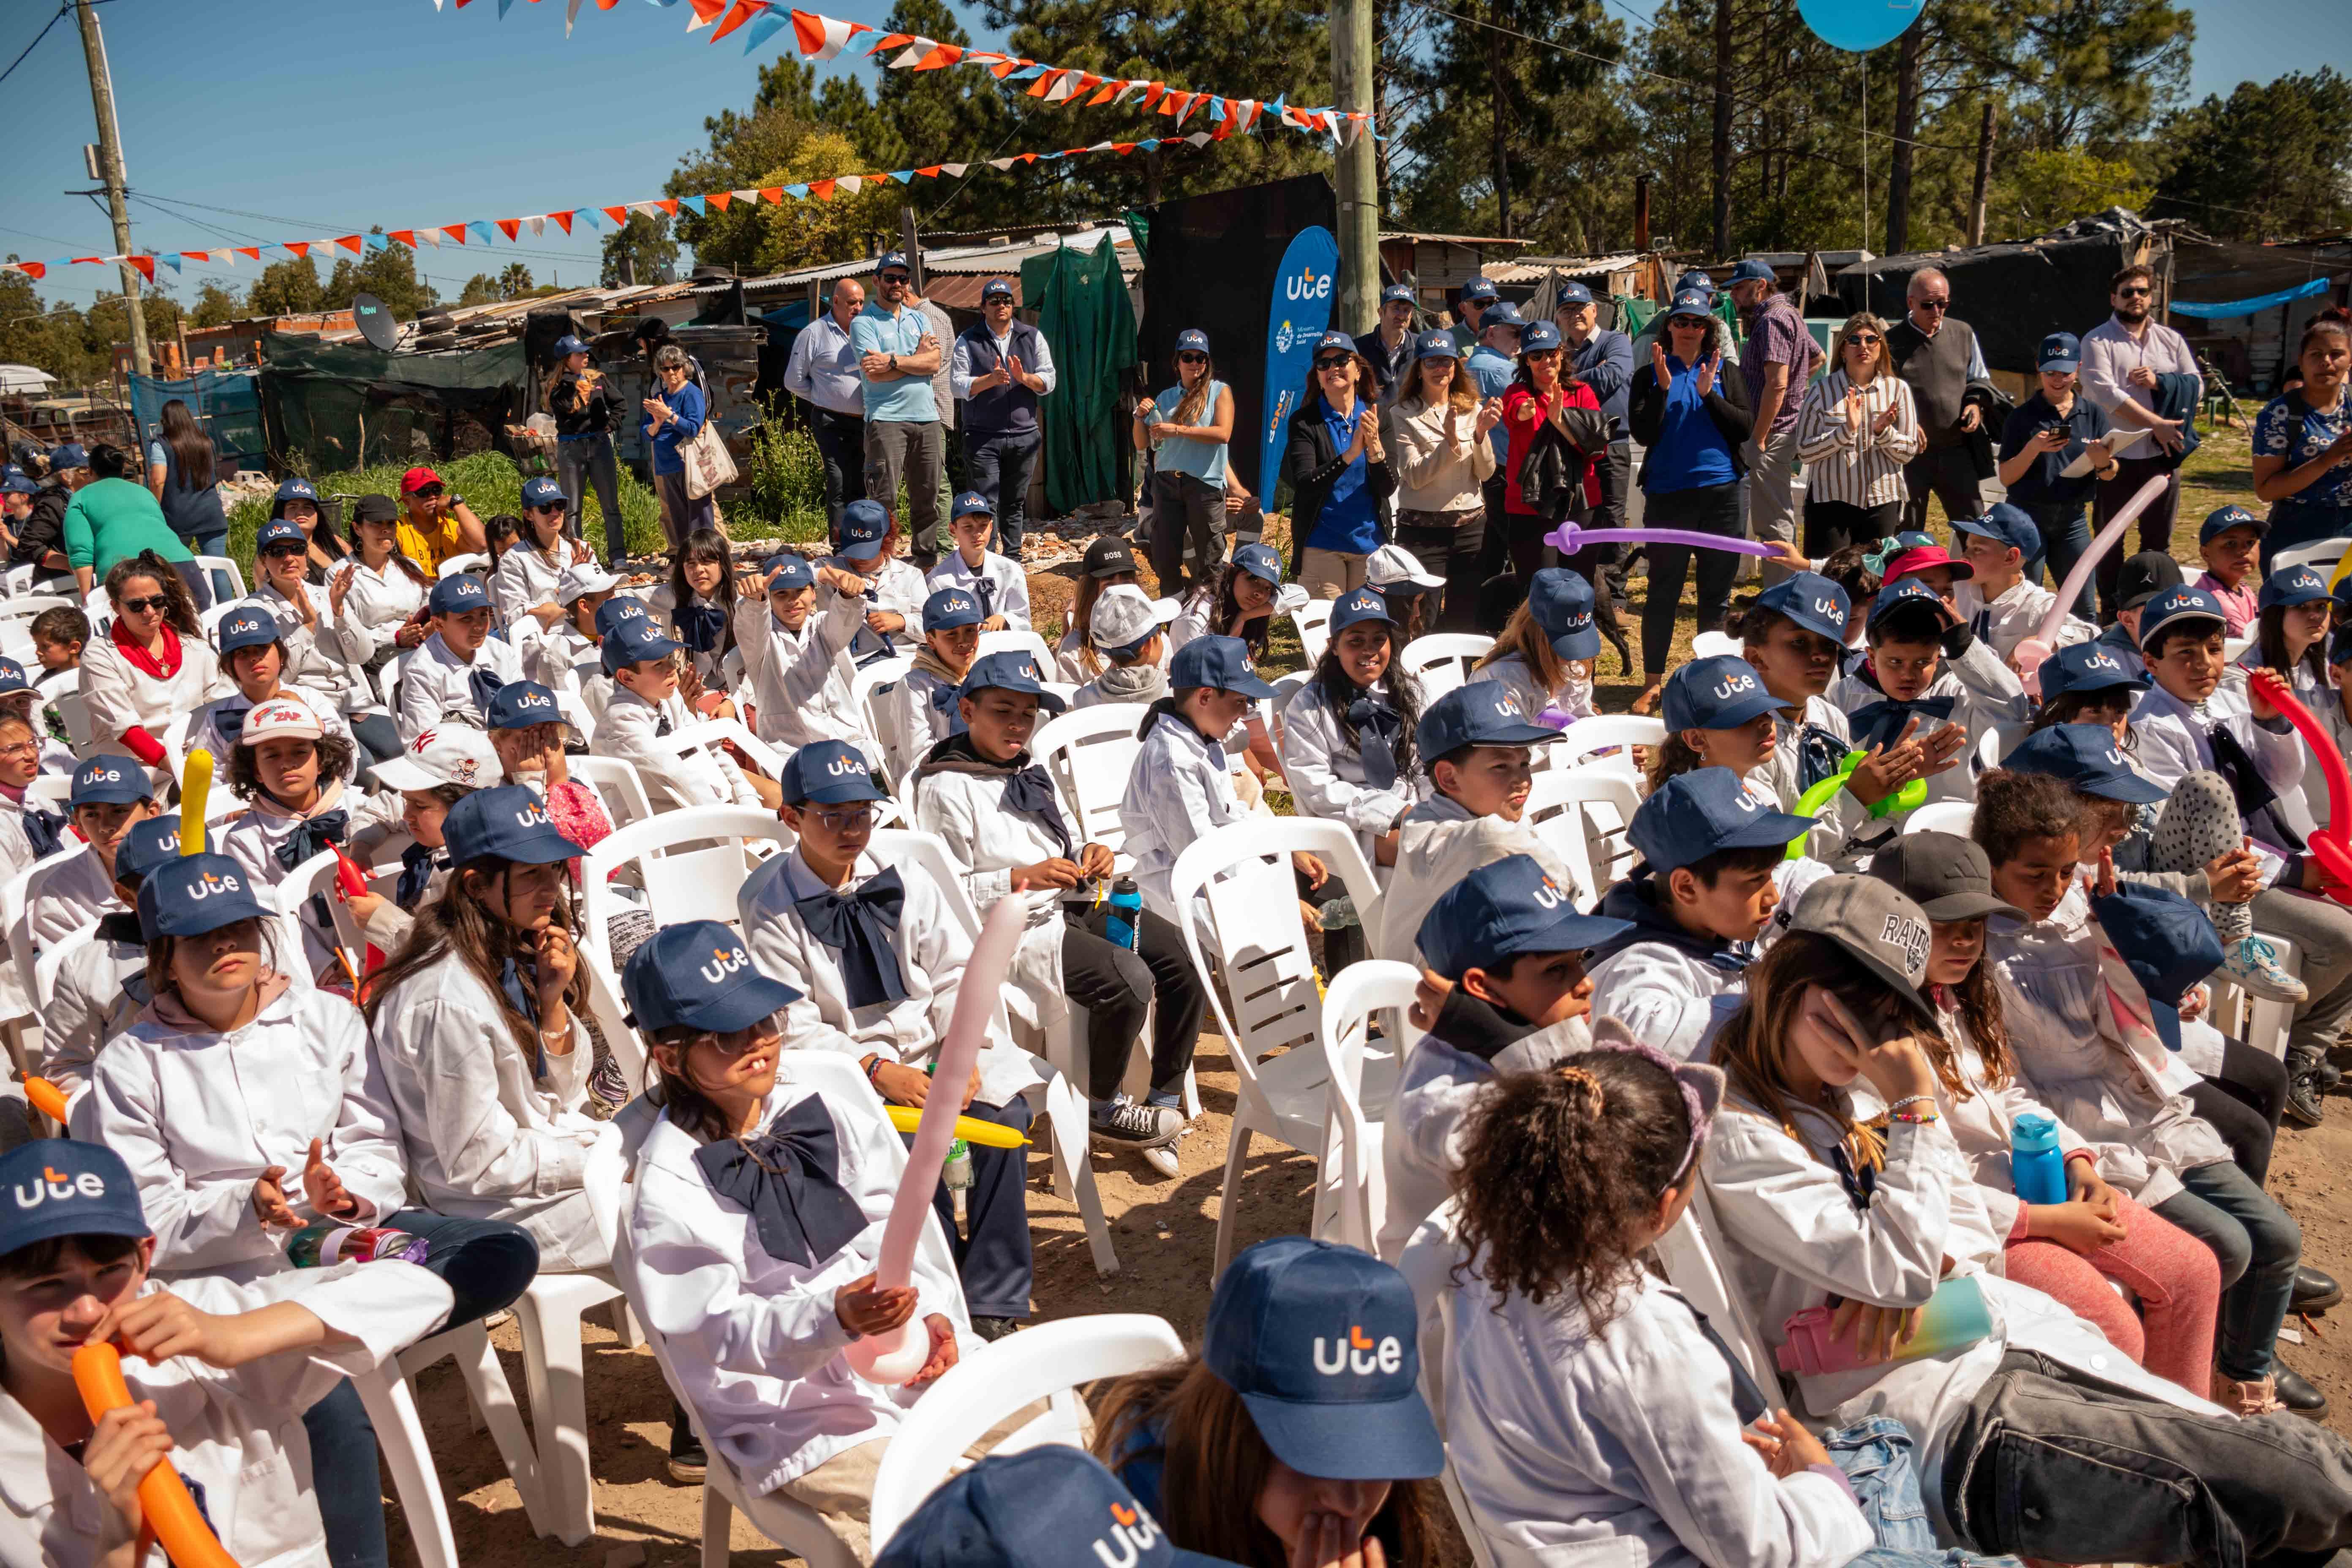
[1797,313,1924,560]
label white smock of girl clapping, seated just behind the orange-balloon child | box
[73,990,407,1281]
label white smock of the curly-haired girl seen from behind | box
[1444,1258,1875,1568]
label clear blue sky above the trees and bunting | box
[0,0,2352,303]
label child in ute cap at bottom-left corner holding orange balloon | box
[0,1138,452,1568]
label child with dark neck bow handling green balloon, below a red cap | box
[1830,573,2032,804]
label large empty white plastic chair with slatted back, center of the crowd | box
[1171,818,1397,1279]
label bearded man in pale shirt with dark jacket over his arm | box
[2082,266,2204,602]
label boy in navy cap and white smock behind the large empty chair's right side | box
[1374,679,1573,964]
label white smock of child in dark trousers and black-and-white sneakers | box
[908,752,1084,1027]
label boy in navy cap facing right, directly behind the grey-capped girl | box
[1592,769,1813,1060]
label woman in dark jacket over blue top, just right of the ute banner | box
[1282,332,1397,599]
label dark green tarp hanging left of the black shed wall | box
[1021,235,1138,515]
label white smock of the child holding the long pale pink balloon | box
[626,1051,978,1495]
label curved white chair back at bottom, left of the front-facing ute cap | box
[870,1312,1183,1552]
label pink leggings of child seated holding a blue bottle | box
[2006,1194,2220,1399]
